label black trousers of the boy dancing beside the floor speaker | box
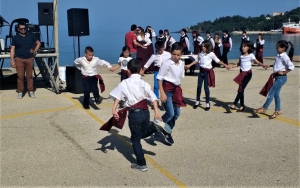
[82,76,100,105]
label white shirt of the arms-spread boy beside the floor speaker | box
[74,57,112,76]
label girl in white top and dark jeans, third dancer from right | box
[185,41,230,111]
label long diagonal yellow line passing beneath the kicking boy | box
[64,94,187,188]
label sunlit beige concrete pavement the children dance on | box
[0,59,300,187]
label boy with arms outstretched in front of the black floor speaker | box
[74,46,114,109]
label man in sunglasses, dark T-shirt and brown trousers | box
[10,23,41,99]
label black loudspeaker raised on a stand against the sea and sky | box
[67,8,90,36]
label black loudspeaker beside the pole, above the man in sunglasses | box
[38,3,54,25]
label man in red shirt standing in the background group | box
[125,24,147,59]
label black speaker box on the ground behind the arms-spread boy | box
[66,66,83,94]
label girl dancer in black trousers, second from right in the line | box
[230,41,268,112]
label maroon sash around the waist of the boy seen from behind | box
[100,99,148,131]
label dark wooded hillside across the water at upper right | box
[188,7,300,32]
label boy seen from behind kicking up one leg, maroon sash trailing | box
[106,59,171,172]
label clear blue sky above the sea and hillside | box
[0,0,300,35]
